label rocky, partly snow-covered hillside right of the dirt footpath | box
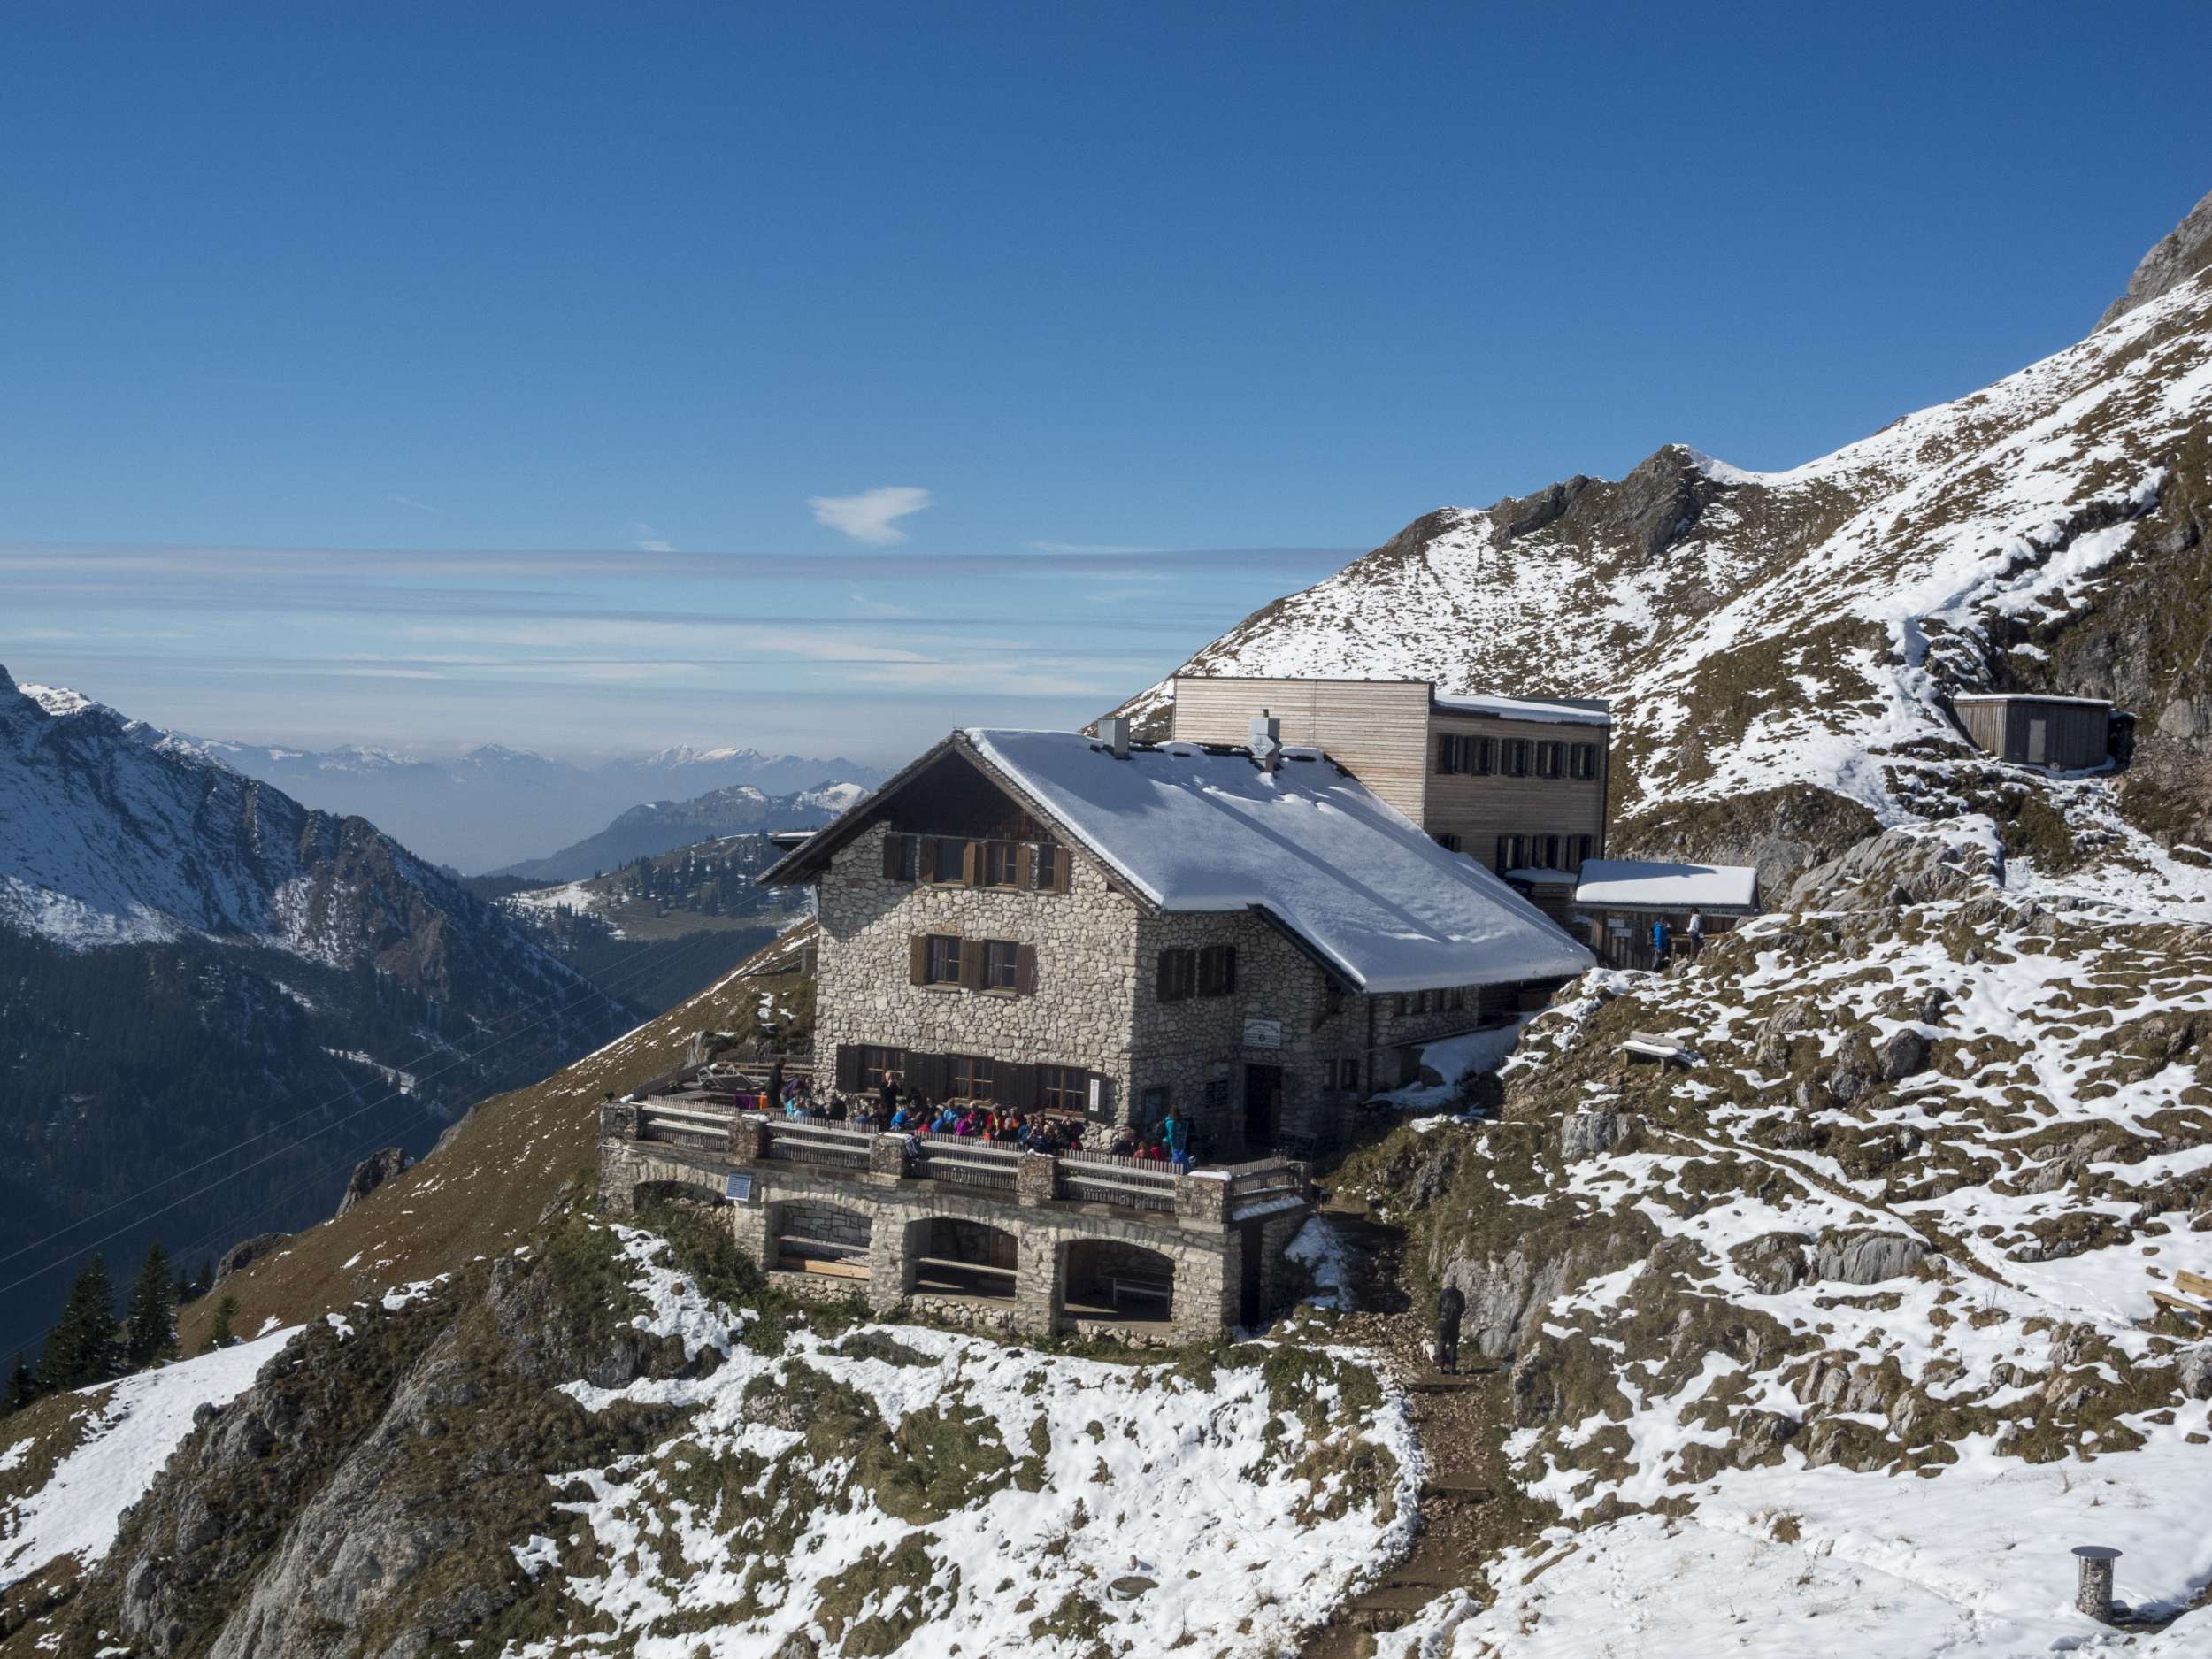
[1367,823,2212,1659]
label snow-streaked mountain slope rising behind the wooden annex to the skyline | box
[1126,200,2212,898]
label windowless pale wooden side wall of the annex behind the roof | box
[1172,675,1433,826]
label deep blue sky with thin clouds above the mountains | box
[0,0,2212,759]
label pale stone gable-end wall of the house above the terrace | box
[814,826,1137,1110]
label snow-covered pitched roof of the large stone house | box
[967,730,1591,994]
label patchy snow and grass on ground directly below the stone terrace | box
[516,1230,1420,1659]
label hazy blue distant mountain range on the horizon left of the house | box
[134,726,883,874]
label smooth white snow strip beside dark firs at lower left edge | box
[0,1330,296,1584]
